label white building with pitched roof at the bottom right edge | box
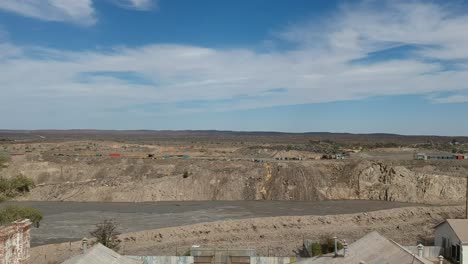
[434,219,468,264]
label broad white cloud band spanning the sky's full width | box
[0,2,468,126]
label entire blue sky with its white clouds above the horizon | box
[0,0,468,135]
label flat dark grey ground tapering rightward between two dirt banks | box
[1,200,428,246]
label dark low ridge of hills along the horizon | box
[0,129,468,144]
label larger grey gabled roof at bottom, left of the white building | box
[297,232,432,264]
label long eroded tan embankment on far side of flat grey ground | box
[1,157,468,204]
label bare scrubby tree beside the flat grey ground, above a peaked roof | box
[89,219,121,250]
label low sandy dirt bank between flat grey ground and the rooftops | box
[31,206,464,264]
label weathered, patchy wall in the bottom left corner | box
[0,220,31,264]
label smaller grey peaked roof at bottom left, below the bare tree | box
[62,244,143,264]
